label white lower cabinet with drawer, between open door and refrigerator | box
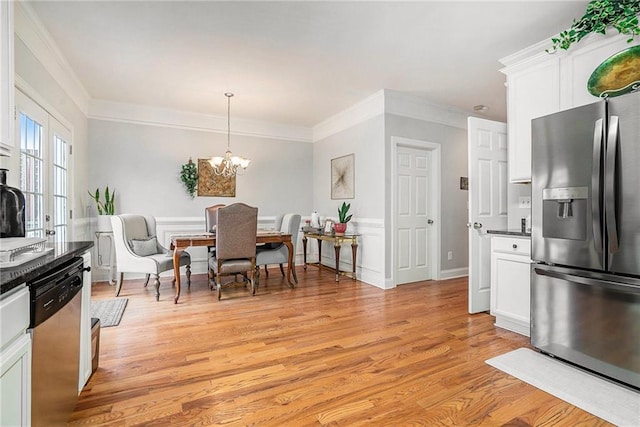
[491,236,531,336]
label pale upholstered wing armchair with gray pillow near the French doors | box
[111,214,191,301]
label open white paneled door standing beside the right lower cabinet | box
[467,117,509,313]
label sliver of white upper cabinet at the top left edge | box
[0,1,14,155]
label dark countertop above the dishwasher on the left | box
[0,241,93,294]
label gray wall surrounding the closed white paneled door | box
[385,114,469,270]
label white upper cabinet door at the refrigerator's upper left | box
[507,58,560,182]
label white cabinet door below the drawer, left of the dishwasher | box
[0,333,31,426]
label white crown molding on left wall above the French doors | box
[14,1,91,115]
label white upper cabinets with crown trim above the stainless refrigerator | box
[500,34,637,182]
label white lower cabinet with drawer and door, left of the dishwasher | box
[0,285,31,426]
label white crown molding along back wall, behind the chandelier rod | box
[88,99,312,142]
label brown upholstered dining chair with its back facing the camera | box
[209,203,258,300]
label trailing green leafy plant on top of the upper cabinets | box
[547,0,640,52]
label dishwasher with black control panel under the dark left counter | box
[27,257,84,427]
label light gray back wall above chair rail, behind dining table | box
[87,119,313,218]
